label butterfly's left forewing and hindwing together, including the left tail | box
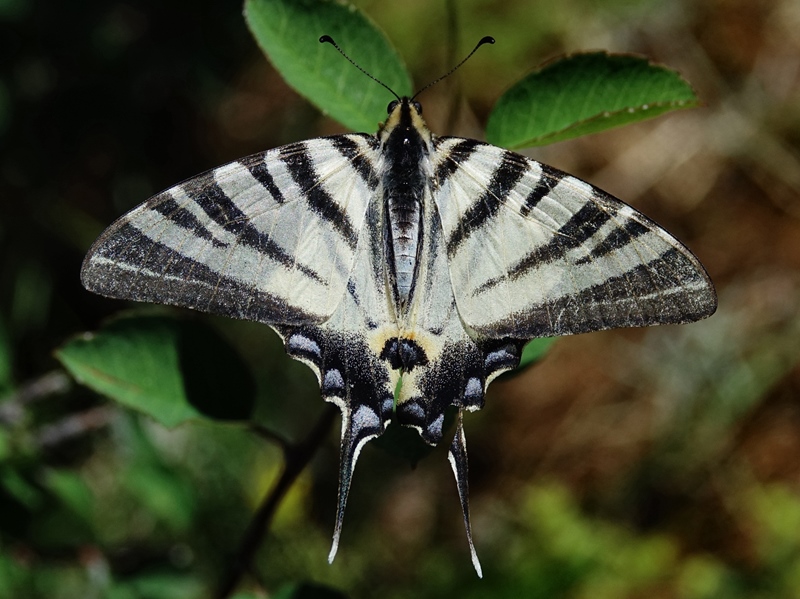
[81,134,398,560]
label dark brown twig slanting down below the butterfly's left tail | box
[214,406,337,599]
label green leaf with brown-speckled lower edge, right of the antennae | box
[486,52,700,148]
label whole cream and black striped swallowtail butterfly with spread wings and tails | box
[81,98,716,575]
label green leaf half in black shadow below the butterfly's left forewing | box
[56,316,255,427]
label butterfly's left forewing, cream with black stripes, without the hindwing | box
[81,134,378,325]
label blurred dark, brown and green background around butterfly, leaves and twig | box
[0,0,800,598]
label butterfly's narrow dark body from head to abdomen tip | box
[378,98,431,315]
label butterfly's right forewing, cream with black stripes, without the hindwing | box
[434,138,716,339]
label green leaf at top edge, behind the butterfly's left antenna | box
[244,0,411,133]
